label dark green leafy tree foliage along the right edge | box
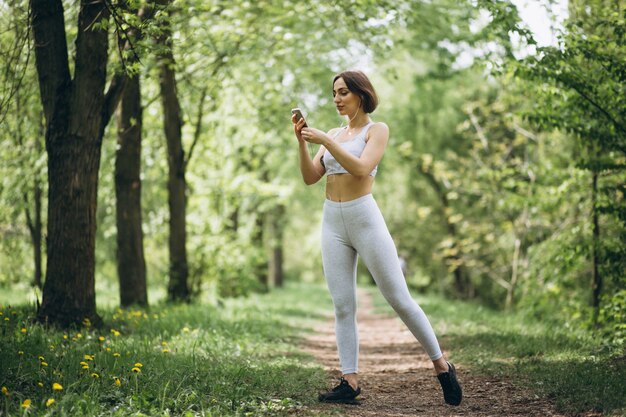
[508,1,626,346]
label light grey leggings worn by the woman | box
[322,194,442,375]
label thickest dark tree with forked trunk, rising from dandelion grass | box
[30,0,122,326]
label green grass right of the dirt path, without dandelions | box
[371,289,626,416]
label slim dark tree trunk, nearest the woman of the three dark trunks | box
[158,1,191,301]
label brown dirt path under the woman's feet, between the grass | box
[305,292,562,417]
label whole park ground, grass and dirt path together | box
[0,284,626,417]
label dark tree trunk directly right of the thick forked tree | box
[115,75,148,307]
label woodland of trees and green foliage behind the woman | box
[0,0,626,354]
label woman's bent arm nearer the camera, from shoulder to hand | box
[302,122,389,177]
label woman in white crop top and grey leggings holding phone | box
[292,71,462,405]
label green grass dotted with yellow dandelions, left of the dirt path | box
[0,285,332,416]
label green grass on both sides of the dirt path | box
[0,284,626,417]
